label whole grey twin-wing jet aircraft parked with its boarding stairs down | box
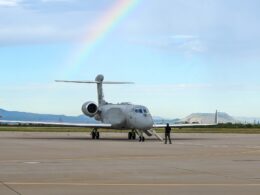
[0,75,218,142]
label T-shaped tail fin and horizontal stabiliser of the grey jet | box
[55,74,134,106]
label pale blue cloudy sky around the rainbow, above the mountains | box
[0,0,260,118]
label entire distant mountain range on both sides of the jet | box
[0,109,260,123]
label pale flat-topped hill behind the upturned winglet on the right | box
[181,112,238,124]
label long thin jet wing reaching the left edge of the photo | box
[0,120,112,128]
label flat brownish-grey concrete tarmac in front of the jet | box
[0,132,260,195]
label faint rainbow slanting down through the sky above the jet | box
[63,0,140,76]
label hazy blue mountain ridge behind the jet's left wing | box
[0,109,97,123]
